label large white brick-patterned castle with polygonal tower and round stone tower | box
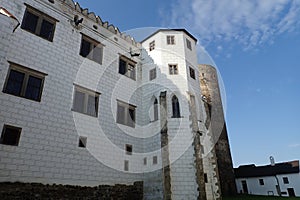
[0,0,235,199]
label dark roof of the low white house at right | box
[234,160,299,178]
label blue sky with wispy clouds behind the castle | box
[78,0,300,166]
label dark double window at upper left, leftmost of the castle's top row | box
[21,6,57,42]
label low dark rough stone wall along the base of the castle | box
[0,182,143,200]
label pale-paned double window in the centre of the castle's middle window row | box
[72,86,100,117]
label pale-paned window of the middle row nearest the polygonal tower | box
[117,101,136,128]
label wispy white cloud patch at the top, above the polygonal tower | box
[164,0,300,49]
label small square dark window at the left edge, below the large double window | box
[0,125,22,146]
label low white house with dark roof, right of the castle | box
[234,160,300,197]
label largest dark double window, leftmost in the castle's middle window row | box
[3,63,45,101]
